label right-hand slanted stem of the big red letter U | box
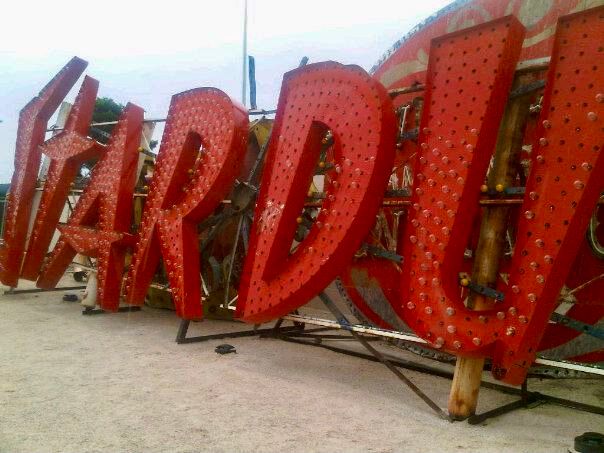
[494,8,604,383]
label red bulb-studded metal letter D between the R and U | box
[237,62,395,322]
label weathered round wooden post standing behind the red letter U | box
[449,77,531,420]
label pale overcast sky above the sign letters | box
[0,0,449,182]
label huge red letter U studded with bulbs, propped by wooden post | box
[400,12,604,384]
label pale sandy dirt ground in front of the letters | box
[0,282,604,453]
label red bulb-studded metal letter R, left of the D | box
[126,88,248,319]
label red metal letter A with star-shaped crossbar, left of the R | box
[38,104,143,310]
